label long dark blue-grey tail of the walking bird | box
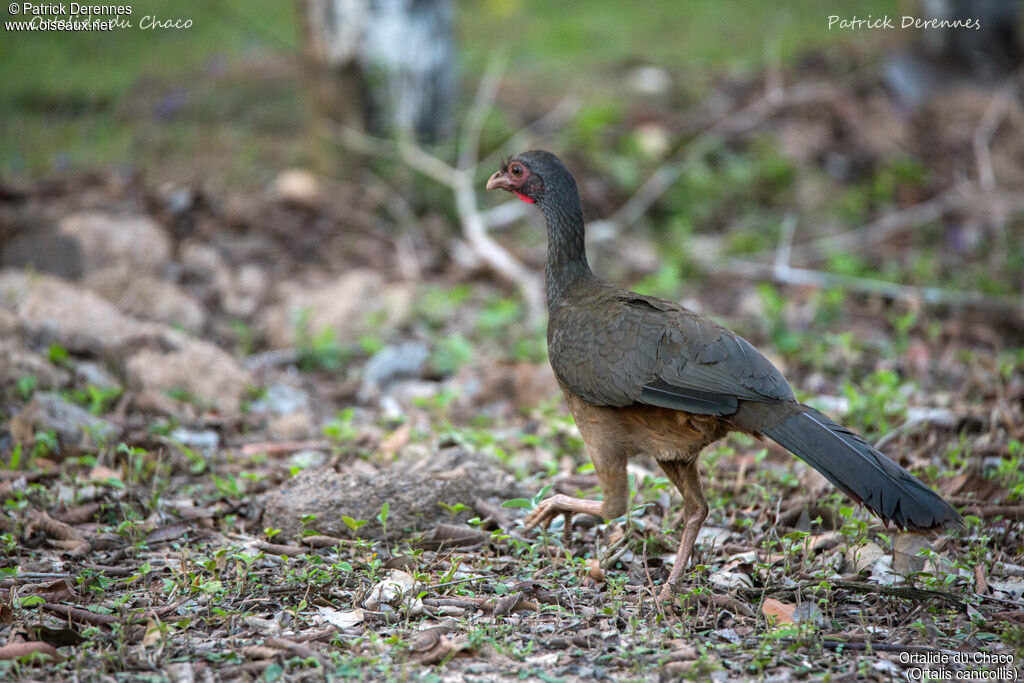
[760,405,964,530]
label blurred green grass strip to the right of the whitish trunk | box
[460,0,898,87]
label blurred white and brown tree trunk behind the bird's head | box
[299,0,456,142]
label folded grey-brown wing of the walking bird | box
[548,290,794,416]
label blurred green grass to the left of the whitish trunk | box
[0,0,301,181]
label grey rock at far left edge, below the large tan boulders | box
[10,391,122,449]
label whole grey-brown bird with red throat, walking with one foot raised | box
[487,151,963,599]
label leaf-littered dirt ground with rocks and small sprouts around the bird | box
[0,50,1024,682]
